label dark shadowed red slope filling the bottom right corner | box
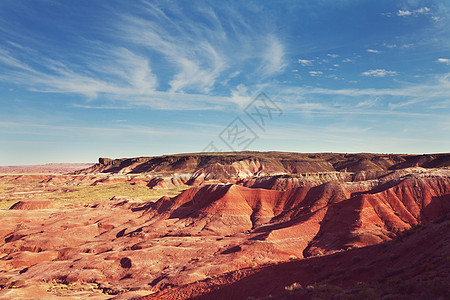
[149,215,450,300]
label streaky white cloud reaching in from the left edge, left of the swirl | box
[0,45,157,98]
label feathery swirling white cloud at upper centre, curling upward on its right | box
[118,4,286,93]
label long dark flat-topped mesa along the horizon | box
[75,151,450,179]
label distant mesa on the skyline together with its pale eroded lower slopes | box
[71,152,450,189]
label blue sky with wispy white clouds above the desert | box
[0,0,450,165]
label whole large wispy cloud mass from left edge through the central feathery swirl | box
[0,3,287,109]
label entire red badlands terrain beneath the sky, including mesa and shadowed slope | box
[0,152,450,299]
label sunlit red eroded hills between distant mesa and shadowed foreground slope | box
[0,168,450,297]
